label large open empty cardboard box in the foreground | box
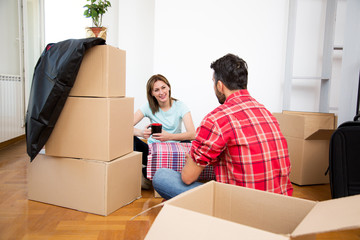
[145,181,360,240]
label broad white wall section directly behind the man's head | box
[154,0,288,126]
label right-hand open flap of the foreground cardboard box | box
[292,195,360,237]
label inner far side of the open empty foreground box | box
[213,182,316,235]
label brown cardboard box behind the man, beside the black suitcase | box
[274,111,337,185]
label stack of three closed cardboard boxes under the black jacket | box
[28,45,142,215]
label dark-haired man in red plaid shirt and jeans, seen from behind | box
[153,54,293,199]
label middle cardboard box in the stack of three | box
[45,97,134,161]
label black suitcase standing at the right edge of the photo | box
[329,71,360,198]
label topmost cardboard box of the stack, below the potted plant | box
[70,45,126,97]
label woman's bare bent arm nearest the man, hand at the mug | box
[153,112,195,141]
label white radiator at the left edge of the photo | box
[0,74,25,143]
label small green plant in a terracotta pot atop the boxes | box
[84,0,111,38]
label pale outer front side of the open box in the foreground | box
[145,205,289,240]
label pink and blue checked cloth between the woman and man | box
[147,142,215,180]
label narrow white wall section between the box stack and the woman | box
[117,0,155,128]
